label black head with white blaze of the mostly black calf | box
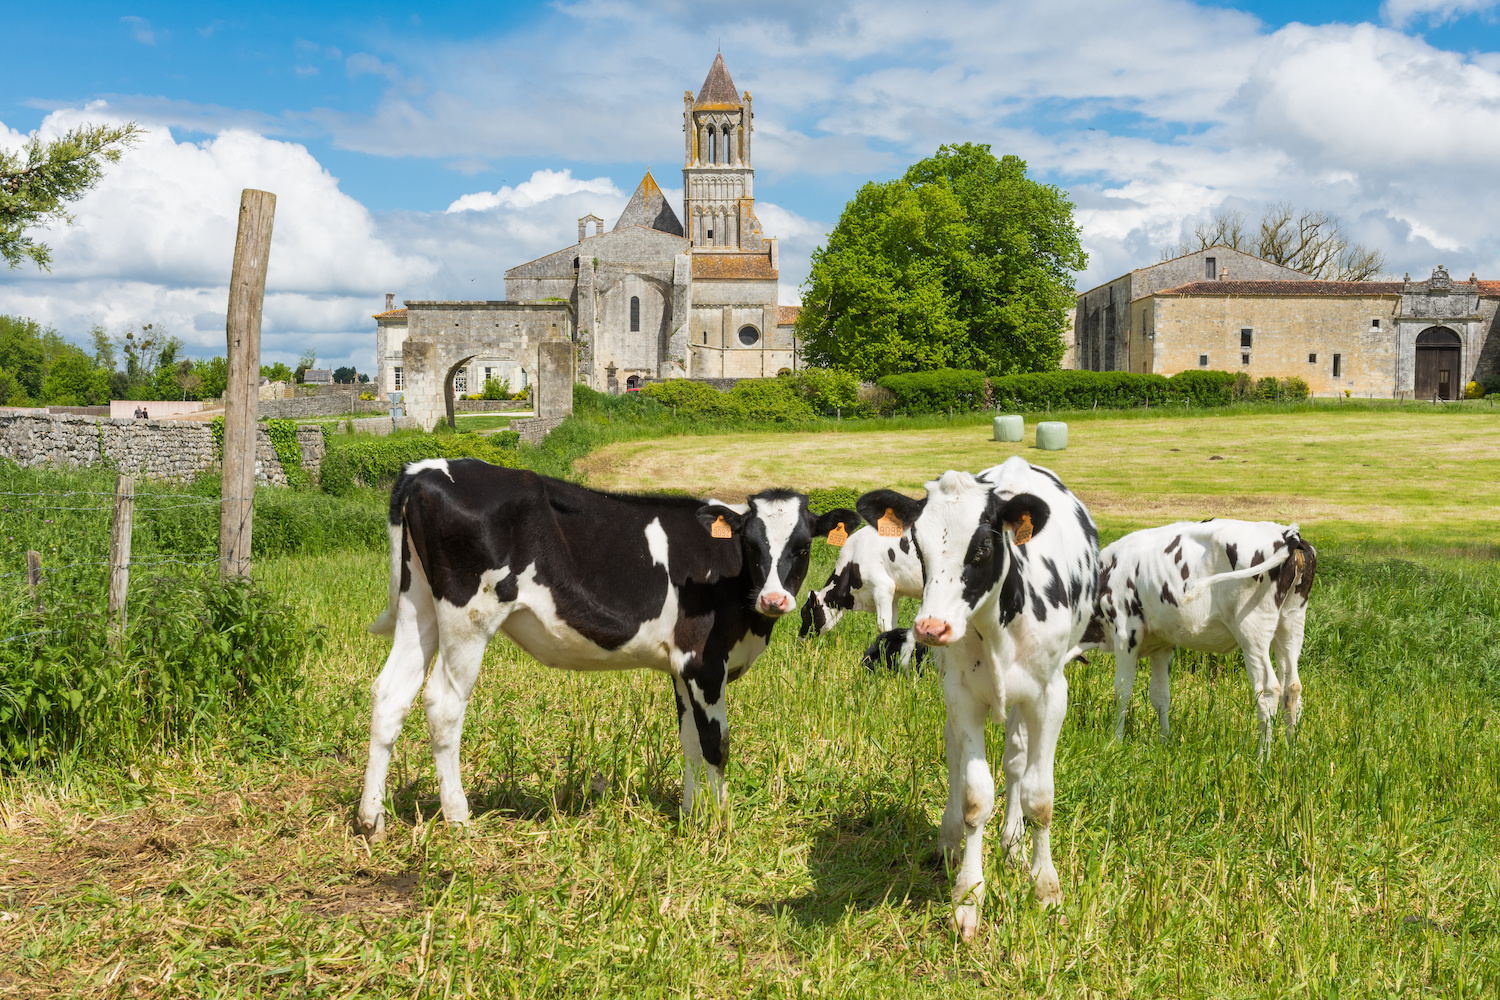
[698,490,860,618]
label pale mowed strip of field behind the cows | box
[581,405,1500,558]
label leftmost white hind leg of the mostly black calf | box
[354,575,438,840]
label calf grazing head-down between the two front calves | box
[798,525,923,639]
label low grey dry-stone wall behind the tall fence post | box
[0,412,324,486]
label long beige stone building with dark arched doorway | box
[1112,267,1500,399]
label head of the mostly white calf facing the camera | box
[858,472,1052,646]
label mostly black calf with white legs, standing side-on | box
[356,459,858,837]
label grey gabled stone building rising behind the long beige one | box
[1062,243,1313,372]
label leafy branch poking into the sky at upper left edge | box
[0,121,144,271]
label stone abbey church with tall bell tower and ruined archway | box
[375,55,797,427]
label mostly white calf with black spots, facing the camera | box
[857,456,1100,940]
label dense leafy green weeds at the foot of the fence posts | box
[0,569,321,769]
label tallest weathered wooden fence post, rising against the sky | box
[219,187,276,576]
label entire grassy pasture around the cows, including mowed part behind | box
[0,412,1500,997]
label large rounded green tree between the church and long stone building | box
[797,142,1088,378]
